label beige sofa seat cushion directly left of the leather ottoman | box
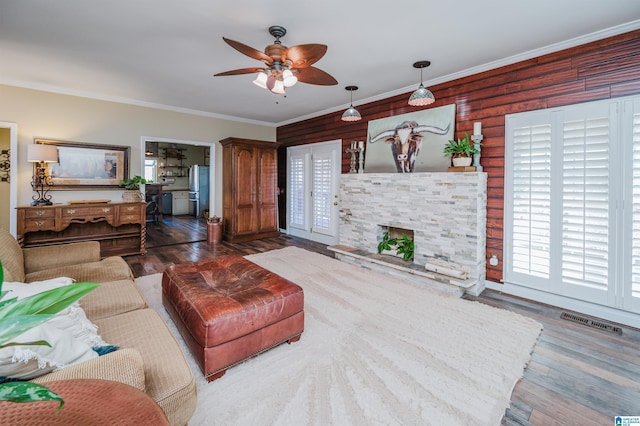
[80,280,147,321]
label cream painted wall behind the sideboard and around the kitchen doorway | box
[0,85,276,223]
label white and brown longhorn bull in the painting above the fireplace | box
[369,121,450,173]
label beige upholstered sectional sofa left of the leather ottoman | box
[0,229,197,425]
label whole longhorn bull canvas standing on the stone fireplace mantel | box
[364,104,456,173]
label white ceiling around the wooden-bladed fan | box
[0,0,640,125]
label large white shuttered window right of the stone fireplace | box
[504,97,640,310]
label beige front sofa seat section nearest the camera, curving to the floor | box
[95,309,197,425]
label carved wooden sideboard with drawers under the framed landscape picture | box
[17,202,146,257]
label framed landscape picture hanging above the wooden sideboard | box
[35,139,130,190]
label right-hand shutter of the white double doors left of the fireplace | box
[311,152,333,232]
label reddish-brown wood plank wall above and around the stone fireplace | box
[277,30,640,282]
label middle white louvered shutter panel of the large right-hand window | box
[562,115,610,290]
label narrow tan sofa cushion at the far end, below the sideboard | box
[24,256,133,283]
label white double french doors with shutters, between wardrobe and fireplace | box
[287,140,342,245]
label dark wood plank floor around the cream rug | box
[125,219,640,426]
